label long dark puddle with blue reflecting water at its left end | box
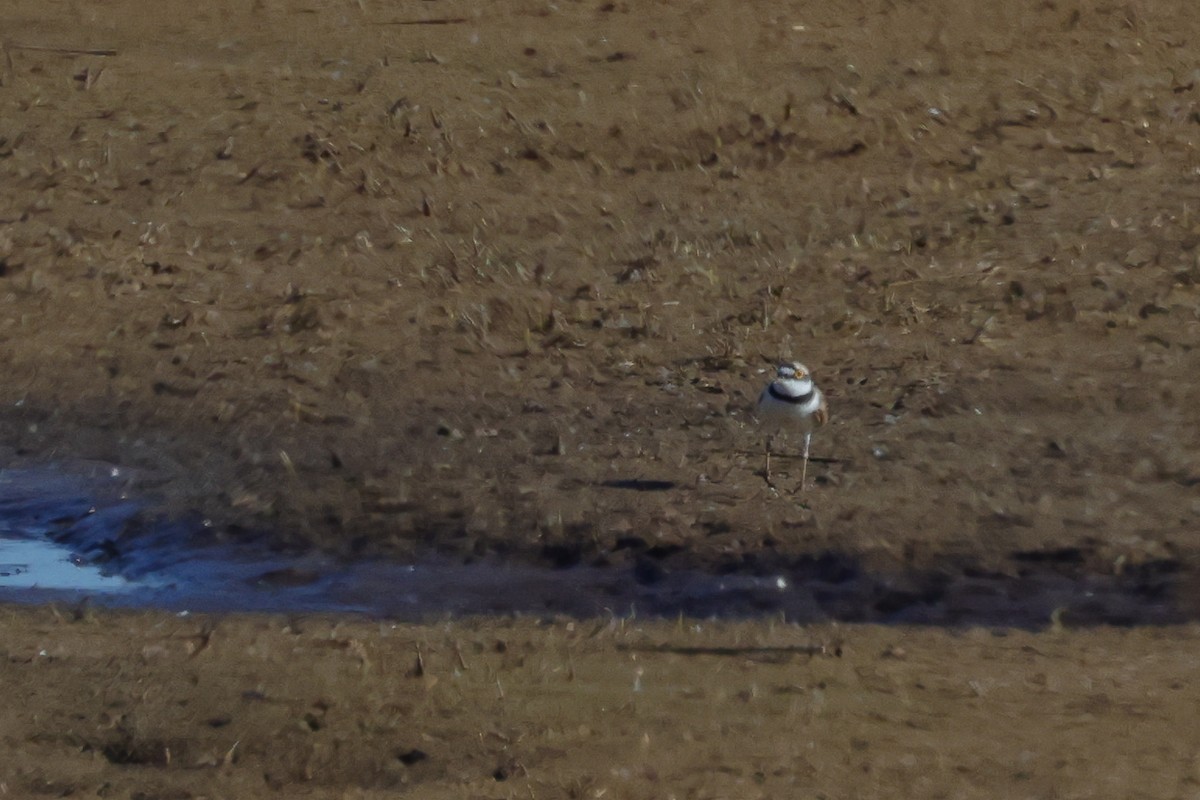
[0,463,1187,628]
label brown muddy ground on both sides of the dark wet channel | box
[0,0,1200,796]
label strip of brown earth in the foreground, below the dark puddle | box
[7,608,1200,800]
